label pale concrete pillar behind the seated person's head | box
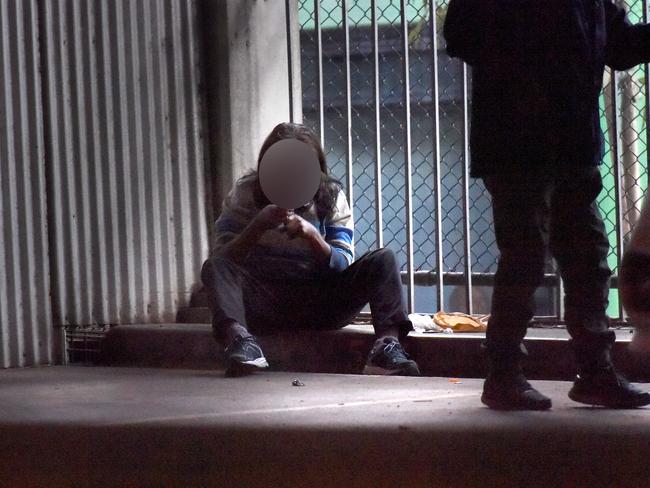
[205,0,302,215]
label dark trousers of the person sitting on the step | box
[201,249,412,342]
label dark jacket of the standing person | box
[444,0,650,177]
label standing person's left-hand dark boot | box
[481,346,552,410]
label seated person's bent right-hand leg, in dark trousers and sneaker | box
[310,248,420,376]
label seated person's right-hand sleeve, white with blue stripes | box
[325,191,354,271]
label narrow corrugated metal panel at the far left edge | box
[0,0,53,368]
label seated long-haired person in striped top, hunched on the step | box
[201,123,420,376]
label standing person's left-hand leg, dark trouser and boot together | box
[481,174,551,409]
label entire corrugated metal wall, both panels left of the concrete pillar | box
[0,0,208,366]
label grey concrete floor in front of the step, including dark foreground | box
[0,367,650,488]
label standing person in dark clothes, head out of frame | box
[444,0,650,410]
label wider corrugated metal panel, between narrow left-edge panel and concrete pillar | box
[41,0,207,324]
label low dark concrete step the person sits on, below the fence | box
[101,324,650,381]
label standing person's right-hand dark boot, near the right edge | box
[569,350,650,408]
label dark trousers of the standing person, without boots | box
[484,167,615,362]
